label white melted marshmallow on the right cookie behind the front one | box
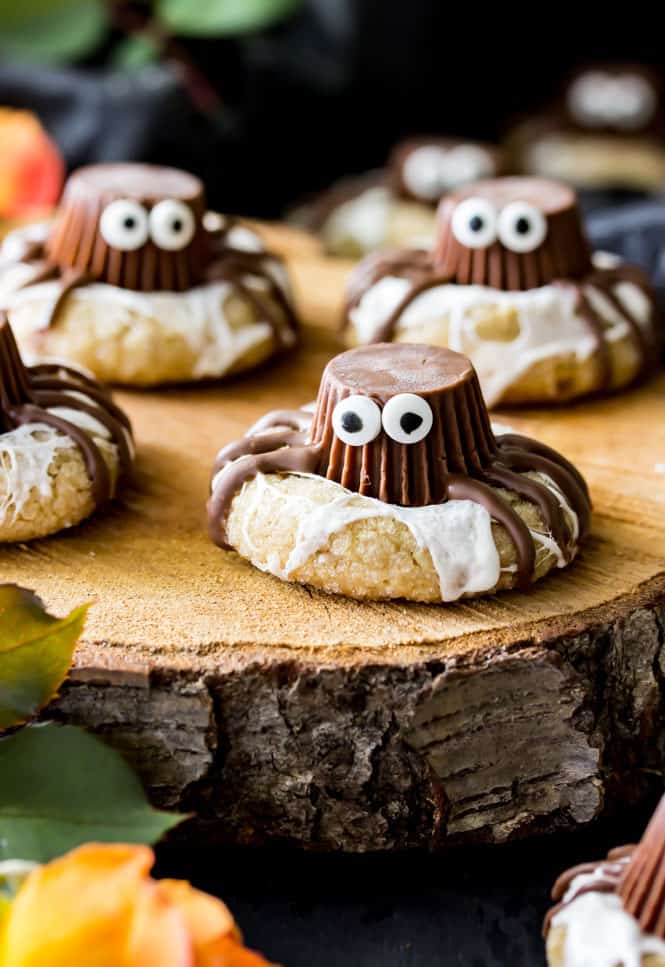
[350,260,651,407]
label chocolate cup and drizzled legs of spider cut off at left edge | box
[0,313,132,506]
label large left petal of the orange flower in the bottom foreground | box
[0,844,154,967]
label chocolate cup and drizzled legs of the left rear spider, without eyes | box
[0,164,296,346]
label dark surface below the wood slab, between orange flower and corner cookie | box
[157,810,648,967]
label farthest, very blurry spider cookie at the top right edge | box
[508,64,665,192]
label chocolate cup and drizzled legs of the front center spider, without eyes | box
[208,343,590,587]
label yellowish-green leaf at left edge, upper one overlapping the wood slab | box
[0,584,88,732]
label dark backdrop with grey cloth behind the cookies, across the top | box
[0,0,663,216]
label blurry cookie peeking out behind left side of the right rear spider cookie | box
[293,137,504,258]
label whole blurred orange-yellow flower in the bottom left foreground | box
[0,843,270,967]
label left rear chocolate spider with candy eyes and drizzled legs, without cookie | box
[0,163,297,348]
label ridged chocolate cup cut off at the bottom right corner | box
[617,796,665,940]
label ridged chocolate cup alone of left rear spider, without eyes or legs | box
[46,164,212,292]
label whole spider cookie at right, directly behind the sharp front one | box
[345,178,661,406]
